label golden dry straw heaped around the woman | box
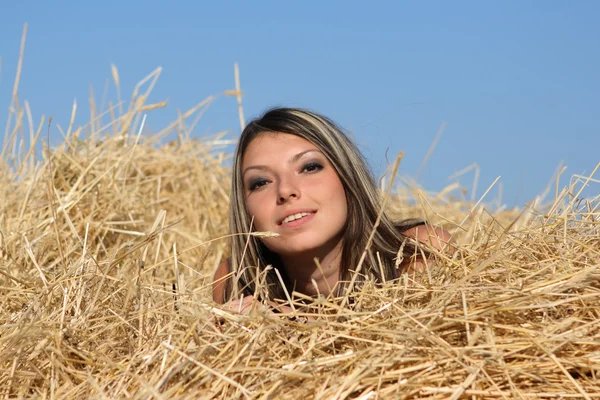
[0,46,600,399]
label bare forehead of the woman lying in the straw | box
[242,132,318,166]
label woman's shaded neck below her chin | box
[280,239,342,296]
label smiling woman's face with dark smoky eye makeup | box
[242,133,348,256]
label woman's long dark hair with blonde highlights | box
[225,108,422,300]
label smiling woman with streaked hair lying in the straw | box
[213,108,450,308]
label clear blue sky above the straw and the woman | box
[0,0,600,206]
